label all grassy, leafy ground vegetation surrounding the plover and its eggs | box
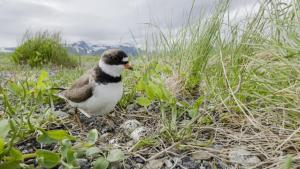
[0,0,300,169]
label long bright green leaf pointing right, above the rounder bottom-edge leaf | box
[37,130,75,144]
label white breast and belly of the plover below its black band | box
[74,82,123,115]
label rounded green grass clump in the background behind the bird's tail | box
[12,31,75,67]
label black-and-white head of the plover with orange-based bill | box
[99,49,133,77]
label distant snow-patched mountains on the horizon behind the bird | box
[0,41,139,56]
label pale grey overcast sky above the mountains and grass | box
[0,0,256,47]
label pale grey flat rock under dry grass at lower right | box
[229,147,261,166]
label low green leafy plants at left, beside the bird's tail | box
[0,70,125,169]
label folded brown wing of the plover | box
[61,67,94,103]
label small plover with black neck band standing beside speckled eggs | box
[58,49,132,120]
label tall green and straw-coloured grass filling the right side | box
[139,0,300,131]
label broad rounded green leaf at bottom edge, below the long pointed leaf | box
[36,150,60,168]
